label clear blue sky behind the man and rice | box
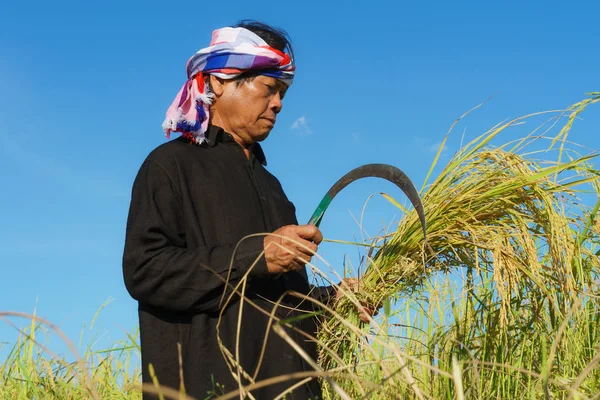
[0,0,600,360]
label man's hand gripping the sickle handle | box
[264,225,323,274]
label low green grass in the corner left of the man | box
[0,312,142,400]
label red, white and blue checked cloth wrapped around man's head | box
[162,27,296,144]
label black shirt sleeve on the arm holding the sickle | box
[123,160,269,312]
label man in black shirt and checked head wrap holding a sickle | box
[123,21,364,399]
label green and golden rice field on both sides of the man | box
[0,93,600,400]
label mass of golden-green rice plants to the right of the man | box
[319,93,600,398]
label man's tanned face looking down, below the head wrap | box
[213,75,287,145]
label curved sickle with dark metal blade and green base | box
[308,164,427,238]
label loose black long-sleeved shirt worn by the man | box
[123,126,331,399]
